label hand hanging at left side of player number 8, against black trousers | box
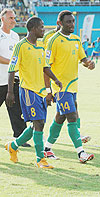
[6,92,15,107]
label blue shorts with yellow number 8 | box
[19,87,47,122]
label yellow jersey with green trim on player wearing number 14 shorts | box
[46,31,86,94]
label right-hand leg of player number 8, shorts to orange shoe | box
[30,94,53,169]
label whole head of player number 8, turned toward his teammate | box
[26,16,44,38]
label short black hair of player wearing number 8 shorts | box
[26,16,42,32]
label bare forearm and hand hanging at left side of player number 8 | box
[6,72,15,107]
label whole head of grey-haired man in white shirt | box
[0,8,16,29]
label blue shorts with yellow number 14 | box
[55,92,76,115]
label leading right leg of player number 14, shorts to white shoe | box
[65,93,94,163]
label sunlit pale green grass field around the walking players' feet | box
[0,61,100,197]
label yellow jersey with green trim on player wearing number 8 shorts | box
[8,38,47,97]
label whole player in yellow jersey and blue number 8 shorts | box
[5,17,62,168]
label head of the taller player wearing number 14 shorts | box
[57,10,75,34]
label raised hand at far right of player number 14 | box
[81,57,95,70]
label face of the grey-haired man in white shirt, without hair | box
[3,11,16,29]
